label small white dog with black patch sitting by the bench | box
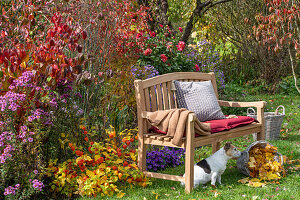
[181,142,241,187]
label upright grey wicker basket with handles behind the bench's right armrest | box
[247,105,285,140]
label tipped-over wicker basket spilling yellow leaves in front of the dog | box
[236,140,283,176]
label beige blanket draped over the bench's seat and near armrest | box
[146,108,211,145]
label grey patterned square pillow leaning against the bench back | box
[174,81,225,122]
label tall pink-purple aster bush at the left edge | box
[0,71,52,199]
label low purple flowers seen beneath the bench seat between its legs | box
[146,147,184,171]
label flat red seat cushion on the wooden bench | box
[205,116,257,133]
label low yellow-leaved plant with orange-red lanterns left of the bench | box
[46,126,150,198]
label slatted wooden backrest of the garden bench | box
[134,72,218,114]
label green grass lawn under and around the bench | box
[81,95,300,200]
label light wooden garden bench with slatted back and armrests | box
[134,72,266,193]
